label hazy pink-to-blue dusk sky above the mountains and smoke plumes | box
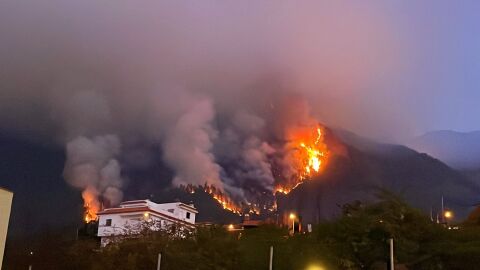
[0,0,480,142]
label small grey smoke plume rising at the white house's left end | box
[64,135,123,209]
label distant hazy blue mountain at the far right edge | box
[407,130,480,170]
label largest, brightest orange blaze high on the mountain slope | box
[275,125,328,194]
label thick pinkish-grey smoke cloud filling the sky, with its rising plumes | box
[0,0,412,204]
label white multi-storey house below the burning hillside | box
[97,200,198,246]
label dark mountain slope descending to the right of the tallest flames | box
[279,131,480,222]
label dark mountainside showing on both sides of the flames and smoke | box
[0,127,480,240]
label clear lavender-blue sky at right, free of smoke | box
[382,1,480,137]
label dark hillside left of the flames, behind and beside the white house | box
[0,130,238,238]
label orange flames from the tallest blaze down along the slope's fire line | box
[176,120,329,215]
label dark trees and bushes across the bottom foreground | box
[5,193,480,270]
